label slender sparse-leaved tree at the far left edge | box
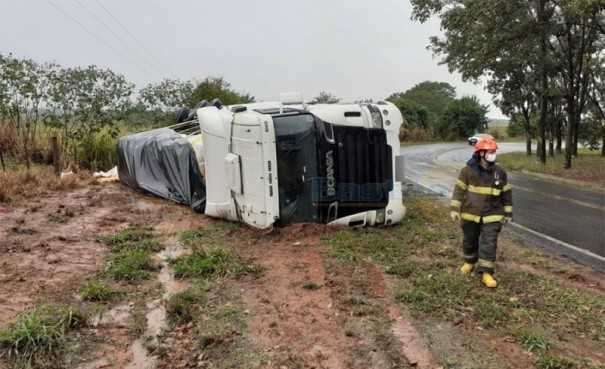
[0,54,56,169]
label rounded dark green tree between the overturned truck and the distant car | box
[437,96,488,139]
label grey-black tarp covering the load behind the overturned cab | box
[118,128,206,212]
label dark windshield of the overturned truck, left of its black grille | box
[273,114,319,225]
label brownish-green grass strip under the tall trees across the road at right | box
[498,148,605,184]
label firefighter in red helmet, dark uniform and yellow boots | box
[450,137,513,288]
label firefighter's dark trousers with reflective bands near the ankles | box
[462,221,502,274]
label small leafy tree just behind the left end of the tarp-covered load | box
[47,65,134,168]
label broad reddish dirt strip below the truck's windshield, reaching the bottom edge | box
[236,228,353,369]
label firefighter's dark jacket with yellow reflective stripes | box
[450,157,513,223]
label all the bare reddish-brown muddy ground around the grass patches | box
[0,183,605,369]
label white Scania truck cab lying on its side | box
[197,94,406,228]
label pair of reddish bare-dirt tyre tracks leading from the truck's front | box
[232,225,441,369]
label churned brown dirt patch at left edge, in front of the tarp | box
[0,186,127,324]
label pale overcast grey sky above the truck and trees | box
[0,0,506,119]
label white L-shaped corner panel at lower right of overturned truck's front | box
[328,182,406,227]
